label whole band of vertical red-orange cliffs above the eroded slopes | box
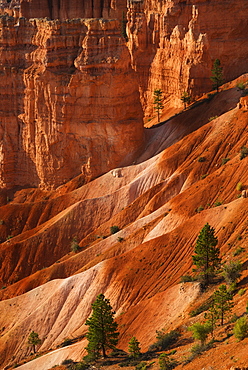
[0,0,248,188]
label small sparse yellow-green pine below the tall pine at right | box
[213,284,233,325]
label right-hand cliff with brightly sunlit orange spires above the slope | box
[127,0,248,117]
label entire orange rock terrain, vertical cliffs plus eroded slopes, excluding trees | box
[0,0,248,370]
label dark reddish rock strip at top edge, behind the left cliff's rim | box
[20,0,126,20]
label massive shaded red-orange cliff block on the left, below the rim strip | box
[0,16,143,188]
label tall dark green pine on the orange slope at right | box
[192,223,221,287]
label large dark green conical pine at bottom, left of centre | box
[85,294,119,361]
